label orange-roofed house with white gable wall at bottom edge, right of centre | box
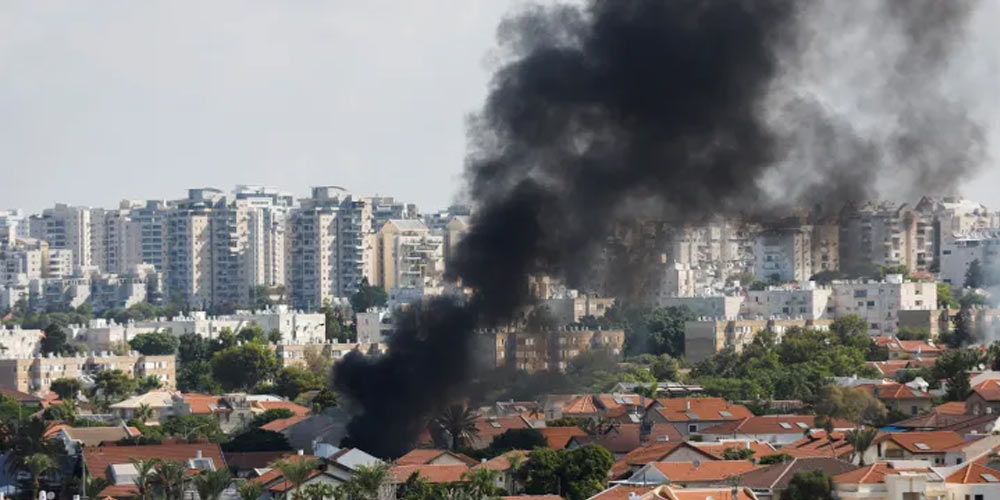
[622,460,757,488]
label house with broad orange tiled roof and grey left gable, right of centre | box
[645,398,753,437]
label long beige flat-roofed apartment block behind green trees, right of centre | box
[684,318,833,362]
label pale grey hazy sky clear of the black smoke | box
[0,0,1000,211]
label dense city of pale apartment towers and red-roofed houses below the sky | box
[0,186,1000,500]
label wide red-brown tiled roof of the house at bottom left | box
[83,442,226,479]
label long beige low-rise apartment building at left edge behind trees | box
[0,354,177,394]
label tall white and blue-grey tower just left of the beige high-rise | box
[289,186,374,310]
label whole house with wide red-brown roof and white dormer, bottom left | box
[83,441,227,498]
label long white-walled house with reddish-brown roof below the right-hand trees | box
[701,415,854,446]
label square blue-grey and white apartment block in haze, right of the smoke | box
[754,226,813,282]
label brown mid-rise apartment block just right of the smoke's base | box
[482,327,625,373]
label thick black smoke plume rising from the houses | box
[335,0,984,456]
